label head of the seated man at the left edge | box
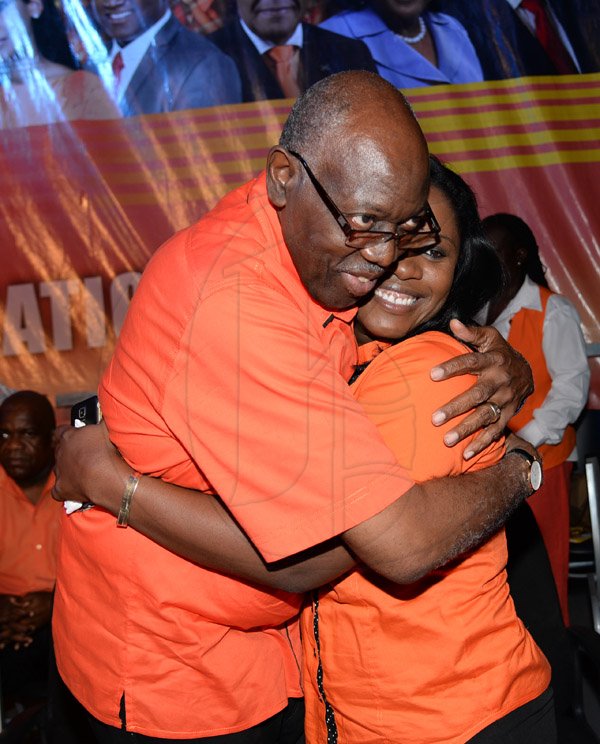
[0,390,56,487]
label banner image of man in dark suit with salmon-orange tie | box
[209,0,376,101]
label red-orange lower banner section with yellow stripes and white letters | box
[0,74,600,408]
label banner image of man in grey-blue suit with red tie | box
[92,0,240,116]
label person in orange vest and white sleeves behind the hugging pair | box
[483,214,590,624]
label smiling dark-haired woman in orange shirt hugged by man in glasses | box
[302,159,555,744]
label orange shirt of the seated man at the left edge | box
[0,468,62,595]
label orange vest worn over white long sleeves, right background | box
[508,287,575,468]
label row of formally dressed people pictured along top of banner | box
[0,0,600,128]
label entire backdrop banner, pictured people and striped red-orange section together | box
[0,0,600,408]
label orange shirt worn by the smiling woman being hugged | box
[302,332,550,744]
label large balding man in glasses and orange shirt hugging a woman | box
[54,72,530,744]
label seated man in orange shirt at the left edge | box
[0,390,60,708]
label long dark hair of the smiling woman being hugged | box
[400,155,505,336]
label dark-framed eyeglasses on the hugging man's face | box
[288,150,441,251]
